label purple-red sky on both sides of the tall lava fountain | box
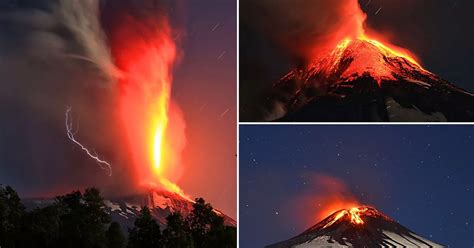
[0,0,237,218]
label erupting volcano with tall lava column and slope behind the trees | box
[107,13,236,226]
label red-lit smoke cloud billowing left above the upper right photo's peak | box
[240,0,365,63]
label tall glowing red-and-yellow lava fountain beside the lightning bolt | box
[113,17,188,198]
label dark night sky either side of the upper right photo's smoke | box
[239,0,474,121]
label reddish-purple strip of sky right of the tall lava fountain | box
[173,0,237,218]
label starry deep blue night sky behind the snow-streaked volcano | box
[239,125,474,248]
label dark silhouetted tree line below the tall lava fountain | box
[0,185,237,248]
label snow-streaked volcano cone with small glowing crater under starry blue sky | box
[267,206,443,248]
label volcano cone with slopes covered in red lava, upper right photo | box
[272,38,474,122]
